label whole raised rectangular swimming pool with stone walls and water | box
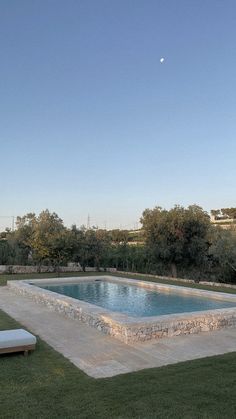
[8,275,236,344]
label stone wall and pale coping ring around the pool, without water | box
[7,275,236,343]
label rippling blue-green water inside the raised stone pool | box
[41,280,236,317]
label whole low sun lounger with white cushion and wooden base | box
[0,329,36,355]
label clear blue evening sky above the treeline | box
[0,0,236,227]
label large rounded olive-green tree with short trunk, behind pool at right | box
[141,205,210,276]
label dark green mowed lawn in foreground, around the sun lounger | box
[0,311,236,419]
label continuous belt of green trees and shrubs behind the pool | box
[0,205,236,282]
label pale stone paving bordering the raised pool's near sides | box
[0,287,236,378]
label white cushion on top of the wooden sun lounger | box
[0,329,36,349]
